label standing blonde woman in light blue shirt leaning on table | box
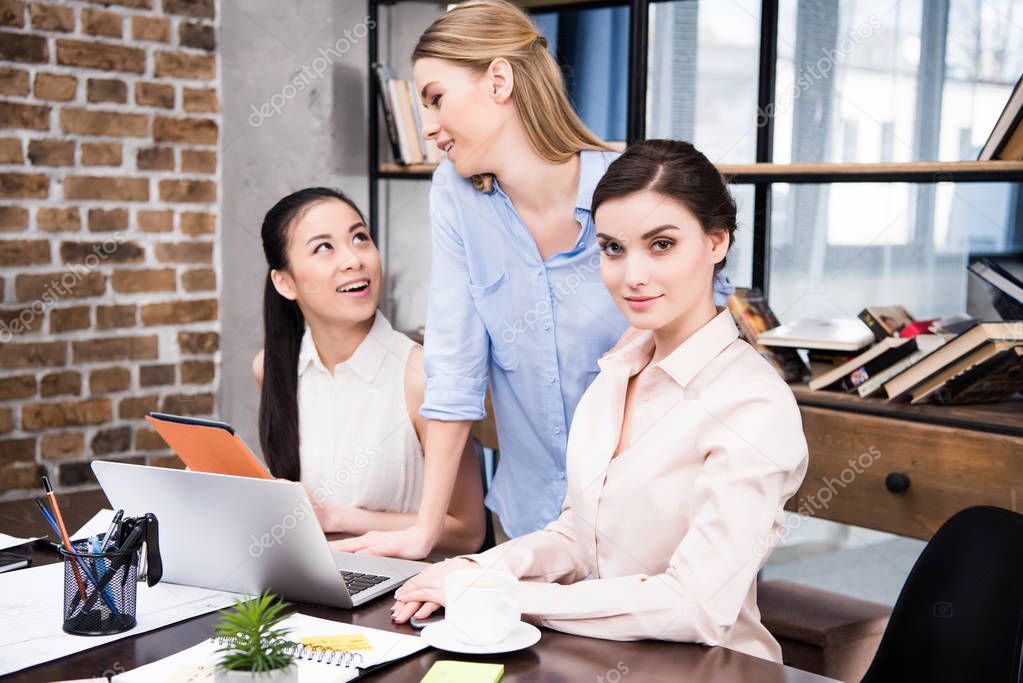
[339,0,730,558]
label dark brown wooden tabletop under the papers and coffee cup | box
[0,491,832,683]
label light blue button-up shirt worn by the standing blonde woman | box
[419,150,732,536]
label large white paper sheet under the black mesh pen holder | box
[0,560,242,676]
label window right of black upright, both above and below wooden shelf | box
[768,0,1023,320]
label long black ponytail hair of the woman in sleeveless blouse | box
[259,187,365,482]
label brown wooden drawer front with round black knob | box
[786,385,1023,540]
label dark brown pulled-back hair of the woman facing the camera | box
[590,140,737,272]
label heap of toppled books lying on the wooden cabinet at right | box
[744,259,1023,405]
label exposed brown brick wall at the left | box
[0,0,221,499]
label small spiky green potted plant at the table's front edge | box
[214,591,299,683]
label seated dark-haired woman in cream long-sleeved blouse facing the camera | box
[393,140,807,662]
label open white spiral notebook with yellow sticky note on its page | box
[112,613,427,683]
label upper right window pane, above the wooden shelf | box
[774,0,1023,163]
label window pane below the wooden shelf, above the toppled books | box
[769,183,1018,321]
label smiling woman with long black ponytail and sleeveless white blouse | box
[253,187,485,552]
